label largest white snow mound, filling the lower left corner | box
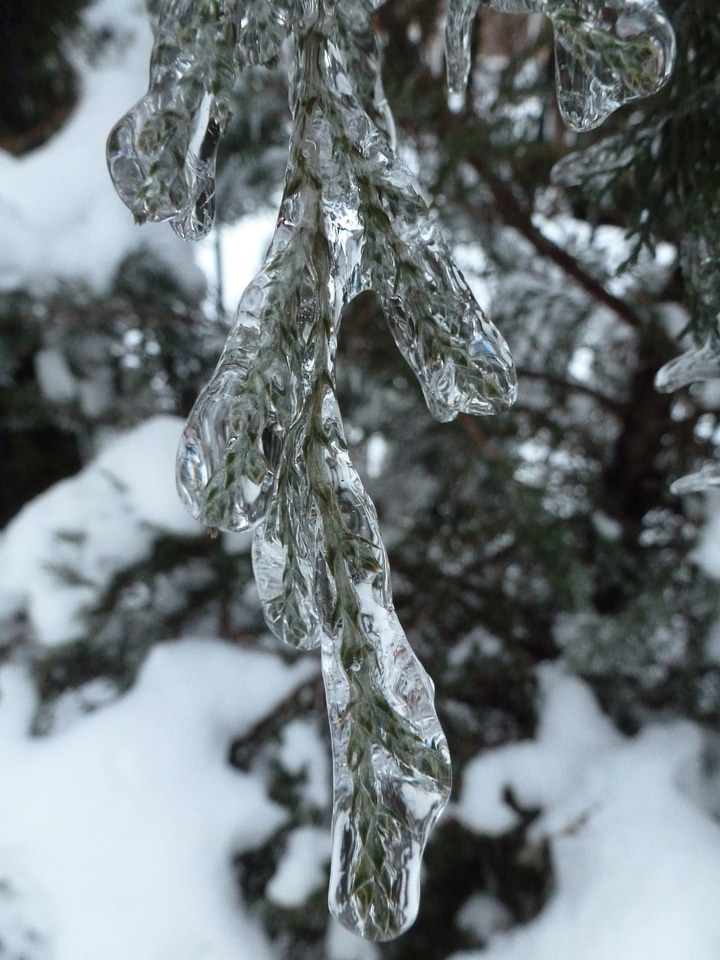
[0,640,317,960]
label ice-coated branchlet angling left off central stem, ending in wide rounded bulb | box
[176,219,307,532]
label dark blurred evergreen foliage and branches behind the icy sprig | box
[0,0,720,960]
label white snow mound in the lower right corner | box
[453,669,720,960]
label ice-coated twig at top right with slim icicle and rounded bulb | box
[446,0,675,130]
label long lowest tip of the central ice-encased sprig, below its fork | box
[272,383,451,940]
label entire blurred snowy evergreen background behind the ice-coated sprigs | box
[0,0,720,960]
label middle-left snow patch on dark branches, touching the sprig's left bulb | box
[0,416,205,644]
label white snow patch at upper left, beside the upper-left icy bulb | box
[0,0,203,290]
